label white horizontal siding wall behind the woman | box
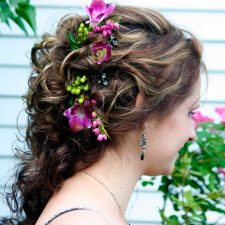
[0,0,225,225]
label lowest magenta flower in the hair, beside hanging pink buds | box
[63,103,92,132]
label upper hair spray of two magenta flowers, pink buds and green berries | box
[68,0,120,64]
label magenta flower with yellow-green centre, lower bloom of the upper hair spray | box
[91,41,112,64]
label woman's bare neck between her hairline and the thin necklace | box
[83,138,143,212]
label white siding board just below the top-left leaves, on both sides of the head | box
[0,37,225,70]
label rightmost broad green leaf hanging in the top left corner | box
[15,3,36,34]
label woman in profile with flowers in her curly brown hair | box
[1,0,203,225]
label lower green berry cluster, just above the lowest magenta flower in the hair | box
[66,75,90,104]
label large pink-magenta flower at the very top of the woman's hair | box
[84,0,115,26]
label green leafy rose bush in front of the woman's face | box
[142,122,225,225]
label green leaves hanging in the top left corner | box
[0,0,36,35]
